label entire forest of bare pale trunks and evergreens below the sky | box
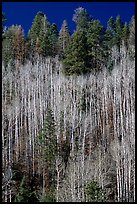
[2,7,135,202]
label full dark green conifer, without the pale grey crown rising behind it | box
[63,31,89,75]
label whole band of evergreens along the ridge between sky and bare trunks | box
[2,7,135,75]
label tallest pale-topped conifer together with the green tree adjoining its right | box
[63,8,106,75]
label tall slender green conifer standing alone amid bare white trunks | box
[37,108,57,192]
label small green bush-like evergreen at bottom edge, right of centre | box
[85,181,105,202]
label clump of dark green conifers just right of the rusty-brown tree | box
[28,12,58,57]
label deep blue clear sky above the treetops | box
[2,2,135,35]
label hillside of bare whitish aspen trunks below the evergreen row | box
[2,43,135,202]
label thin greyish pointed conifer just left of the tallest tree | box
[58,20,71,57]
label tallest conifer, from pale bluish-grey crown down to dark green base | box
[63,7,92,75]
